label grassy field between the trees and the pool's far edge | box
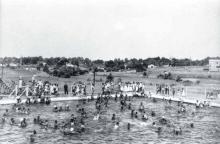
[0,67,220,102]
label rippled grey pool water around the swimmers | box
[0,98,220,144]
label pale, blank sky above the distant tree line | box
[0,0,220,60]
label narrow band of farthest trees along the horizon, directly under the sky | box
[0,56,217,70]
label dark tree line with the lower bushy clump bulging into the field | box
[0,56,219,77]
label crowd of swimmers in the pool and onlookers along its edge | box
[1,75,213,142]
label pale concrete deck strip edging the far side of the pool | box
[0,92,220,108]
